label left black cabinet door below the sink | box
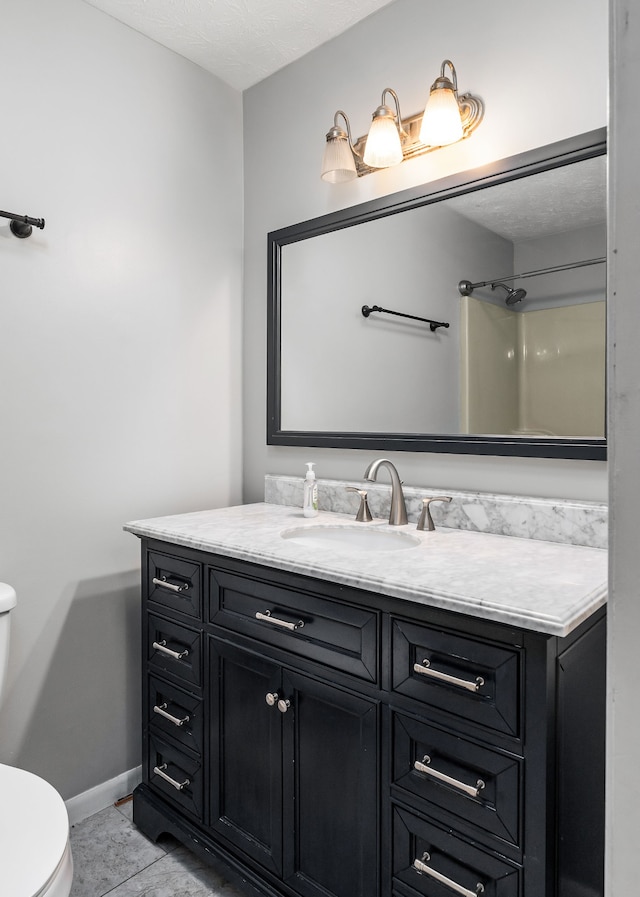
[210,638,282,875]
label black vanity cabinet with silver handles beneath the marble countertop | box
[134,540,605,897]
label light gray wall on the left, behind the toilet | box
[0,0,242,798]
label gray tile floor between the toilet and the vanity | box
[71,802,243,897]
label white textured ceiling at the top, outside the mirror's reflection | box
[85,0,392,90]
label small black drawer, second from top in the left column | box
[147,614,202,686]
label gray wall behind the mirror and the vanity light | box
[244,0,608,500]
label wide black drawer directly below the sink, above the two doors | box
[209,569,378,682]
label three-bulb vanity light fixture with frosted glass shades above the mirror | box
[320,59,484,184]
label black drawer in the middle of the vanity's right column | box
[392,714,523,849]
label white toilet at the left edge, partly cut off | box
[0,582,73,897]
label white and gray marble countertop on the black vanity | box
[124,503,607,636]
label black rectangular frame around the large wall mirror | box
[267,128,607,461]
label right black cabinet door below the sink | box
[282,672,379,897]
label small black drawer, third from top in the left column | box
[147,676,204,754]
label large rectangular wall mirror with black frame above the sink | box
[267,130,606,459]
